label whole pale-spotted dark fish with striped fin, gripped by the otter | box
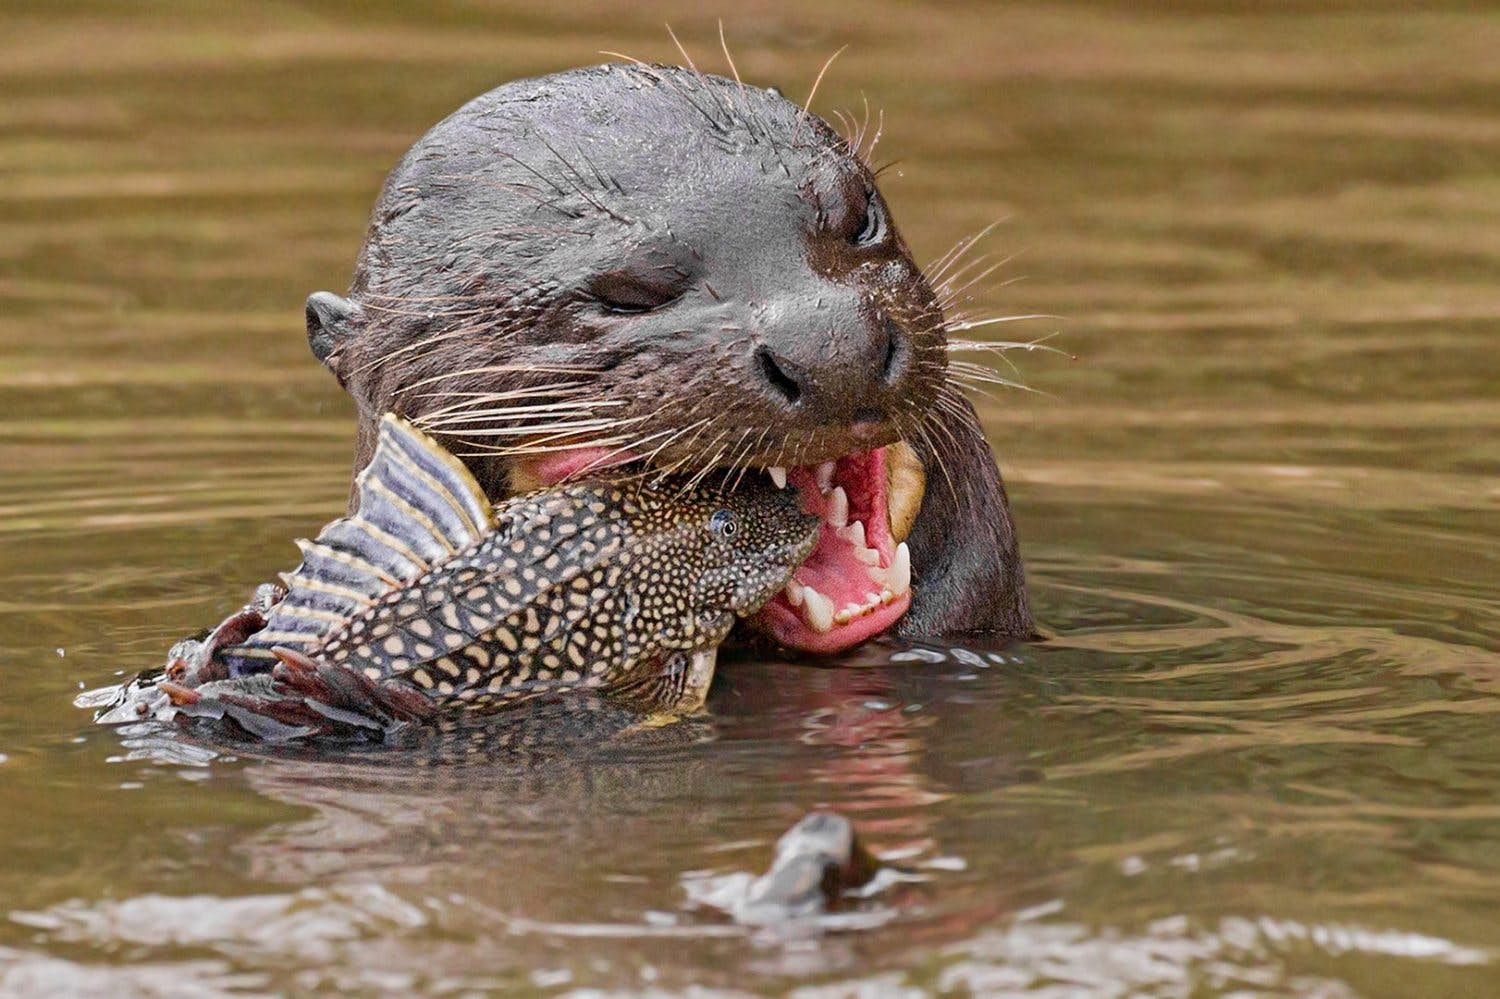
[139,416,818,740]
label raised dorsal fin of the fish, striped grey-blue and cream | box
[222,413,495,672]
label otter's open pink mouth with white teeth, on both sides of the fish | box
[525,443,926,654]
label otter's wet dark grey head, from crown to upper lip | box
[321,66,947,479]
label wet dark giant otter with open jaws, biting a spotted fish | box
[308,65,1034,653]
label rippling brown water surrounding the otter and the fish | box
[0,0,1500,998]
